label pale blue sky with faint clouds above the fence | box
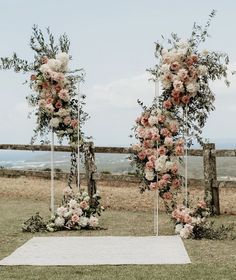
[0,0,236,147]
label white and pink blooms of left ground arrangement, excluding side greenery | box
[47,187,104,232]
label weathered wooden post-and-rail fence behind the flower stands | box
[0,142,236,215]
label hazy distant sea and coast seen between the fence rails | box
[0,150,236,178]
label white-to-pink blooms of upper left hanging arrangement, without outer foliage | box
[29,52,78,146]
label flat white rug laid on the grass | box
[0,236,191,265]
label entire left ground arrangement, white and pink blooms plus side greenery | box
[22,190,104,232]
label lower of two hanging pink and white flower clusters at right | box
[132,103,184,210]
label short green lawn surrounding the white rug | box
[0,198,236,280]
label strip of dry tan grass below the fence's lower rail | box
[0,177,236,214]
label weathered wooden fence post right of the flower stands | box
[203,143,220,215]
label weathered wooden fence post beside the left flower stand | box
[83,142,97,205]
